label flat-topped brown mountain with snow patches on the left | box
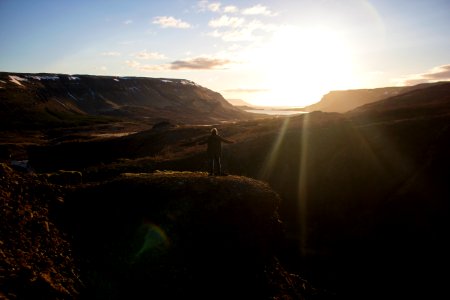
[0,72,251,128]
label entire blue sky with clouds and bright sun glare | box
[0,0,450,107]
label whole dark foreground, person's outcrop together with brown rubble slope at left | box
[0,168,331,299]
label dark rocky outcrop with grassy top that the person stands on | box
[66,172,317,299]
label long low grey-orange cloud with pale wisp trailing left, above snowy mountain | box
[125,57,232,71]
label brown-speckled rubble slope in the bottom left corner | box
[0,164,82,299]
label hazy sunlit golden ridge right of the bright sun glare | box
[302,82,450,113]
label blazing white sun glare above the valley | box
[250,26,357,107]
